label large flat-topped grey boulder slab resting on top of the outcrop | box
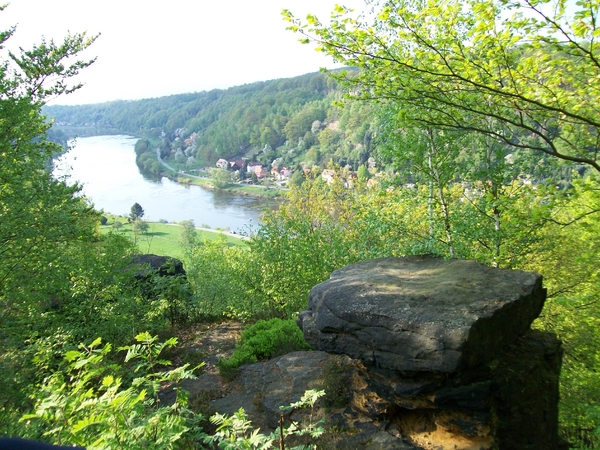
[298,256,545,373]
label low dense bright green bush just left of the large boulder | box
[217,318,310,378]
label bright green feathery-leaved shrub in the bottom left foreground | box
[21,333,201,449]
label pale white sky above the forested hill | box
[0,0,364,104]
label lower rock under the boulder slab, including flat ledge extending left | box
[211,331,562,450]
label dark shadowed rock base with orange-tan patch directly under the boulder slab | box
[351,330,562,449]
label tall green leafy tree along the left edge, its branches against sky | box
[0,6,100,312]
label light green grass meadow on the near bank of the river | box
[100,215,246,258]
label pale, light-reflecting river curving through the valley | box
[54,136,265,232]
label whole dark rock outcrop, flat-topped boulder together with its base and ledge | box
[213,257,562,449]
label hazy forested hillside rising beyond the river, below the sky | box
[44,69,371,168]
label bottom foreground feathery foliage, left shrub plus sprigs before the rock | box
[11,332,324,449]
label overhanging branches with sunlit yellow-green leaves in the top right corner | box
[284,0,600,172]
